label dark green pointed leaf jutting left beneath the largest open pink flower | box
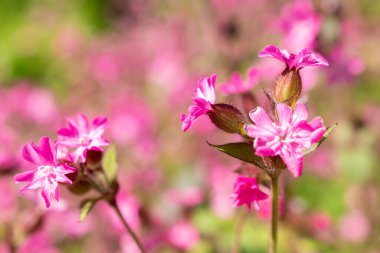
[207,142,266,169]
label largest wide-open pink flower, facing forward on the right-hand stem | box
[245,103,326,177]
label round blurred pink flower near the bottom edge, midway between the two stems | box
[167,221,199,250]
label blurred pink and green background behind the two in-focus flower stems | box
[0,0,380,253]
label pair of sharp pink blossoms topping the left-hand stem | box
[15,114,108,207]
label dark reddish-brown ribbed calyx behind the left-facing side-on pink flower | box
[207,104,246,135]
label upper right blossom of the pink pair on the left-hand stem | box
[57,114,109,162]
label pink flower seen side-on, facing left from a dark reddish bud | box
[181,74,216,132]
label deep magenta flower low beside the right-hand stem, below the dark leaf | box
[231,176,268,211]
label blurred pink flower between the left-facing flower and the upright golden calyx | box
[220,68,260,94]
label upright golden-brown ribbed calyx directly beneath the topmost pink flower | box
[274,68,302,107]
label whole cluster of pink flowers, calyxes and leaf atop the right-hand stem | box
[182,45,329,211]
